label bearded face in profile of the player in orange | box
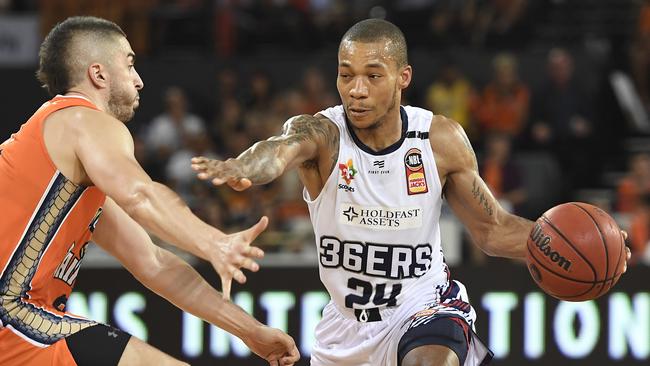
[108,37,144,123]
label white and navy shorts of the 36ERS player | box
[311,281,492,366]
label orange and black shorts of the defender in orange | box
[0,324,131,366]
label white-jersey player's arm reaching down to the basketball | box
[429,116,533,258]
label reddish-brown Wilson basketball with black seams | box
[526,202,626,301]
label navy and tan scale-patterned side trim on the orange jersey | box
[0,172,87,344]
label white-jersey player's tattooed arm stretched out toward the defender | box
[192,115,338,190]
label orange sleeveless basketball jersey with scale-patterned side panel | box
[0,96,106,350]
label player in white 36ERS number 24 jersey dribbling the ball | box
[192,19,628,366]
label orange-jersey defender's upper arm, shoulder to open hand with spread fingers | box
[69,108,267,296]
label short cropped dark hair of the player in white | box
[339,19,408,67]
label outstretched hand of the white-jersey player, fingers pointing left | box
[192,156,252,191]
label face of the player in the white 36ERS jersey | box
[336,41,411,129]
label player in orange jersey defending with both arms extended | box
[0,17,299,366]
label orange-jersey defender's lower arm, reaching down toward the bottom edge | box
[93,198,299,364]
